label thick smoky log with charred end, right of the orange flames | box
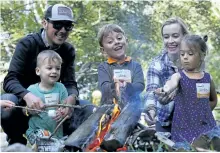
[100,103,141,151]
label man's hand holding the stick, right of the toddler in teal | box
[60,95,76,117]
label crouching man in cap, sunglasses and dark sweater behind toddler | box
[1,4,92,144]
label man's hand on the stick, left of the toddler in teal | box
[23,92,44,114]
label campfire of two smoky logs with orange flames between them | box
[64,77,141,152]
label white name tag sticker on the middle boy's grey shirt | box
[113,69,131,82]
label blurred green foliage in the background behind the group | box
[0,0,220,103]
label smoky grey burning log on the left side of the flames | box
[64,105,114,151]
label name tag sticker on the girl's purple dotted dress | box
[196,83,210,98]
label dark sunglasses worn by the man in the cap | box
[47,19,74,31]
